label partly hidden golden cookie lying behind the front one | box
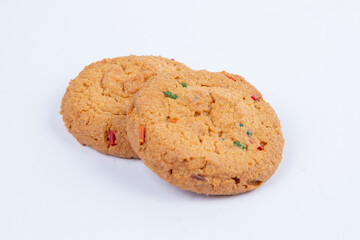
[60,56,191,158]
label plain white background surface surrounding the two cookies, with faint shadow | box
[0,0,360,240]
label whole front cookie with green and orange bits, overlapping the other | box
[127,71,284,195]
